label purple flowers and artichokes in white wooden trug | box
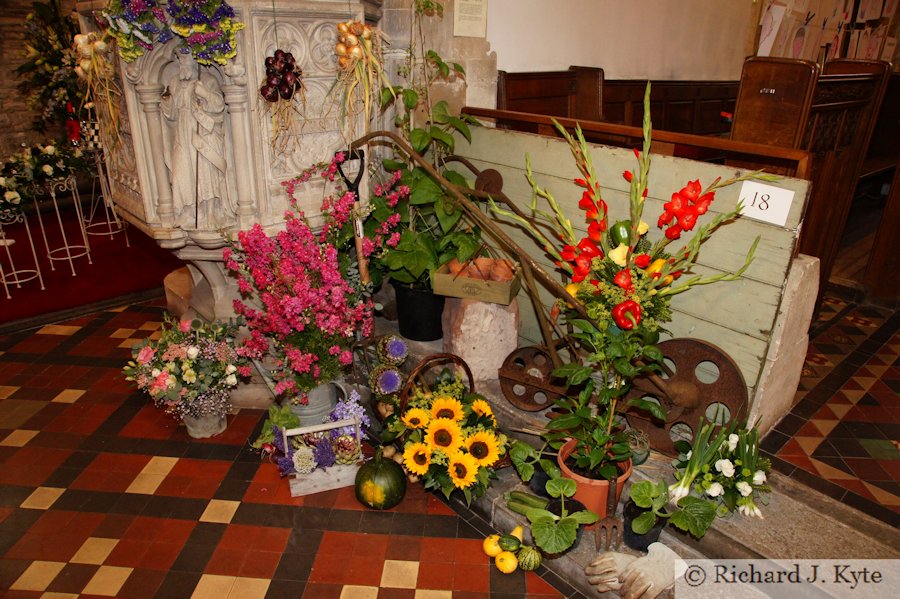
[253,390,371,476]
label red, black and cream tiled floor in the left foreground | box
[0,305,581,599]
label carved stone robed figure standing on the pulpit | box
[160,52,235,229]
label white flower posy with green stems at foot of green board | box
[669,423,771,518]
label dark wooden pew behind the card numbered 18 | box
[731,57,890,297]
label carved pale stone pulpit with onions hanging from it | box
[77,0,382,319]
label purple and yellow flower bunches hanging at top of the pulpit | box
[102,0,244,65]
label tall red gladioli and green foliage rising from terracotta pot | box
[492,84,771,516]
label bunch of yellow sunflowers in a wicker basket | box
[385,369,507,505]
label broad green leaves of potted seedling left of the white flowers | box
[629,480,716,539]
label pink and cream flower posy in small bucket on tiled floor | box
[123,315,251,418]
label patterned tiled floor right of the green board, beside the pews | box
[763,297,900,526]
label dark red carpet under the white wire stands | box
[0,207,184,324]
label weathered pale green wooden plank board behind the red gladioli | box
[457,127,809,406]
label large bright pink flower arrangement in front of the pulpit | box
[224,153,399,403]
